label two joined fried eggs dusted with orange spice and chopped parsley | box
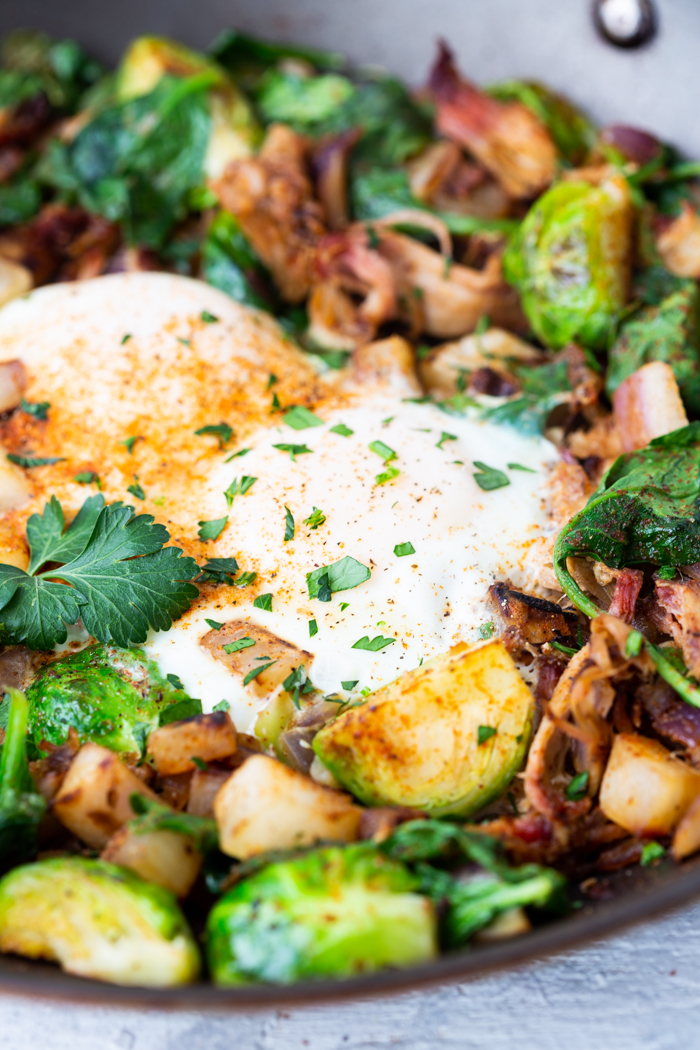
[0,273,555,731]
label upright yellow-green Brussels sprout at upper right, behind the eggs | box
[504,177,632,350]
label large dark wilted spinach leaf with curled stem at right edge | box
[554,423,700,616]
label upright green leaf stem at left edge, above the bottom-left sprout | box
[0,689,46,874]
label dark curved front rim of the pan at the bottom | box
[0,864,700,1011]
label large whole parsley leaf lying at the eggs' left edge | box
[0,494,199,651]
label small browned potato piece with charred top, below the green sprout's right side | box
[148,711,237,776]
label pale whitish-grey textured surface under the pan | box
[0,905,700,1050]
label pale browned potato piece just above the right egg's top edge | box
[419,328,542,398]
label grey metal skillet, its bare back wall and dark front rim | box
[0,0,700,1010]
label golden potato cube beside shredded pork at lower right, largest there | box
[600,733,700,837]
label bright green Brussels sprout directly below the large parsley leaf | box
[27,646,201,755]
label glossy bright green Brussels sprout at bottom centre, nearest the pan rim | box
[202,843,438,985]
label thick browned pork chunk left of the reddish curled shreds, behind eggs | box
[215,124,325,302]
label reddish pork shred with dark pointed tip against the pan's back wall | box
[429,42,556,198]
